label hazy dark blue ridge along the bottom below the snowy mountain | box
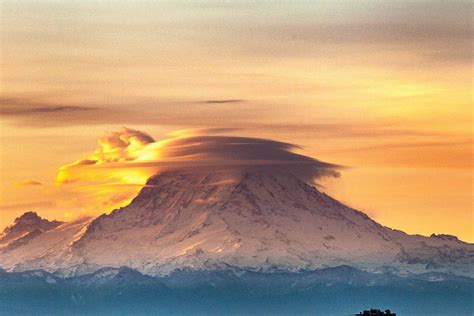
[0,266,474,315]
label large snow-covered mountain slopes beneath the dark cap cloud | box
[0,168,474,277]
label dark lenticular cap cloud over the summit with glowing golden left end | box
[58,128,340,183]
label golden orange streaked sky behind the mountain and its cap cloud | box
[0,0,474,242]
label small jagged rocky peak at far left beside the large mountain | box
[0,212,62,249]
